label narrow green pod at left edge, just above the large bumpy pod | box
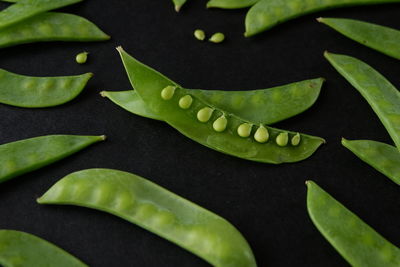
[0,135,105,183]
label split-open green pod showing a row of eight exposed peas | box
[118,48,325,164]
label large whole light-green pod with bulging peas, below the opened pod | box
[37,169,256,267]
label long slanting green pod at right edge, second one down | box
[325,52,400,149]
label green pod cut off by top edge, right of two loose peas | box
[245,0,400,37]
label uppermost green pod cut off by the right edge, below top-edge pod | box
[318,18,400,59]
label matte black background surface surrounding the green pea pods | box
[0,0,400,266]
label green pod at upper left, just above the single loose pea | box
[0,12,110,48]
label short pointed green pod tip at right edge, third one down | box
[342,139,400,185]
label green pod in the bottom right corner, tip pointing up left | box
[307,181,400,267]
